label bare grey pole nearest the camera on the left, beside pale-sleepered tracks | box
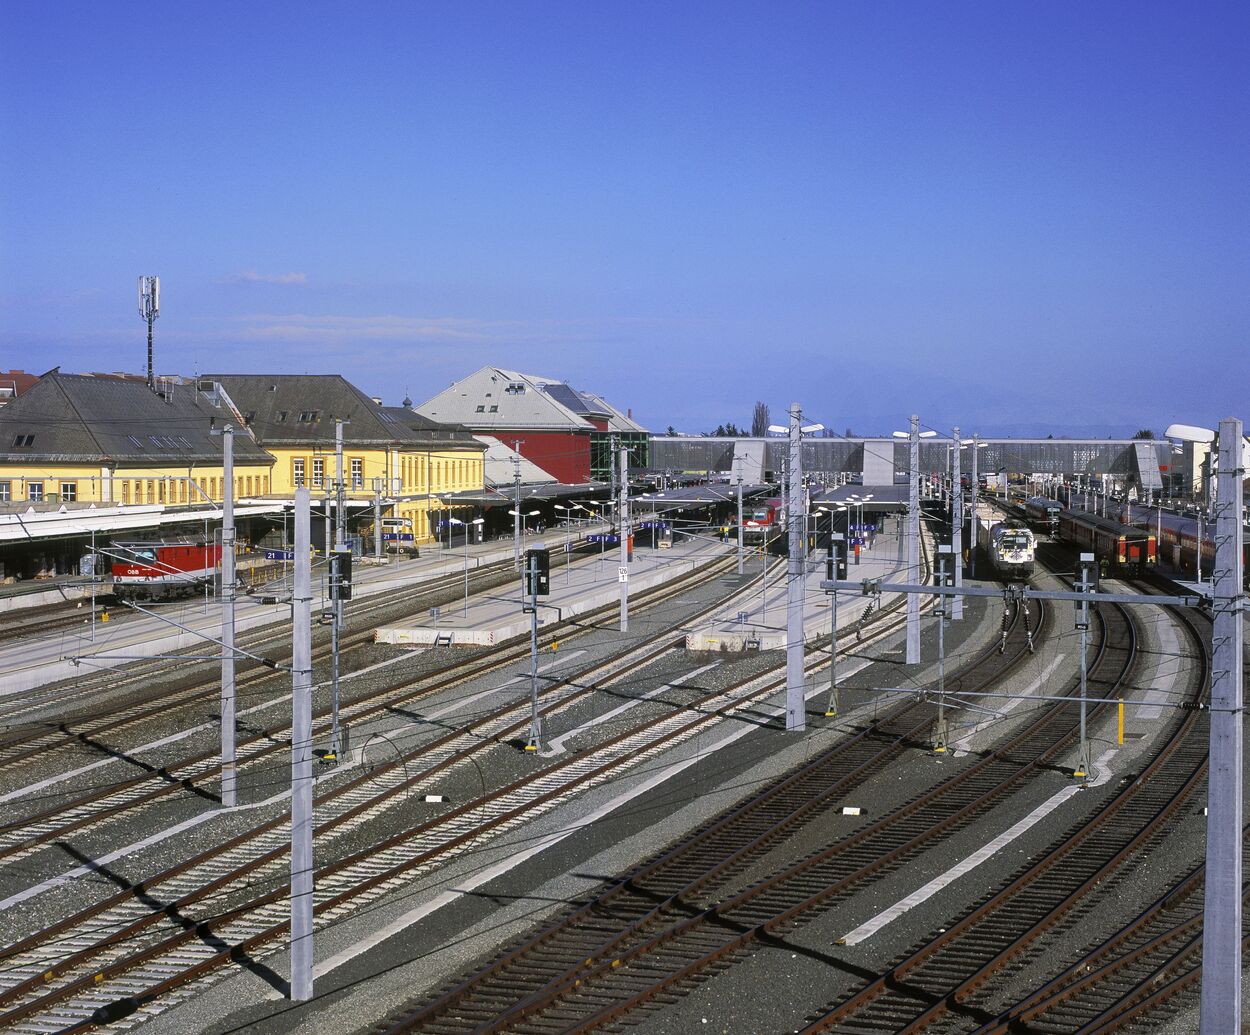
[291,488,313,1000]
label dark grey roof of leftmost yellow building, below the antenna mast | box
[0,373,273,466]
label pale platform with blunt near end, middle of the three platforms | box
[375,539,734,648]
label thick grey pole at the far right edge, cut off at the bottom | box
[1201,418,1245,1035]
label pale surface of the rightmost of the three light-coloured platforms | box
[686,533,906,651]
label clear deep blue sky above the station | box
[0,0,1250,434]
